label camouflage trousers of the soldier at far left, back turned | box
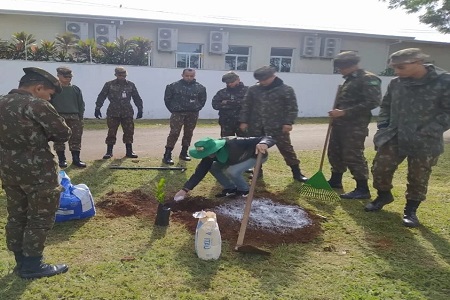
[3,183,61,256]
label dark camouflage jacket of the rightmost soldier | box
[374,65,450,156]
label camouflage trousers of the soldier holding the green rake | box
[328,126,369,180]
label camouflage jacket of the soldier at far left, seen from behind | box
[0,90,71,185]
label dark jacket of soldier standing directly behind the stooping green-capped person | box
[239,77,298,136]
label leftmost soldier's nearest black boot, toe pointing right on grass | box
[19,256,69,279]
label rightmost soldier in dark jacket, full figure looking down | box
[365,48,450,227]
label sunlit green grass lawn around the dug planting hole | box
[0,133,450,300]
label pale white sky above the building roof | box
[0,0,450,43]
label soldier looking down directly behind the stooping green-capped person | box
[239,66,308,182]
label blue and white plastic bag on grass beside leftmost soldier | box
[55,171,95,222]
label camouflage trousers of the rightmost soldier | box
[372,138,439,201]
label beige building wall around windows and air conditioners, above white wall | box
[0,15,450,74]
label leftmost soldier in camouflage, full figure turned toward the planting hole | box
[0,68,71,278]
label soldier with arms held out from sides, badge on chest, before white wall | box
[95,67,143,159]
